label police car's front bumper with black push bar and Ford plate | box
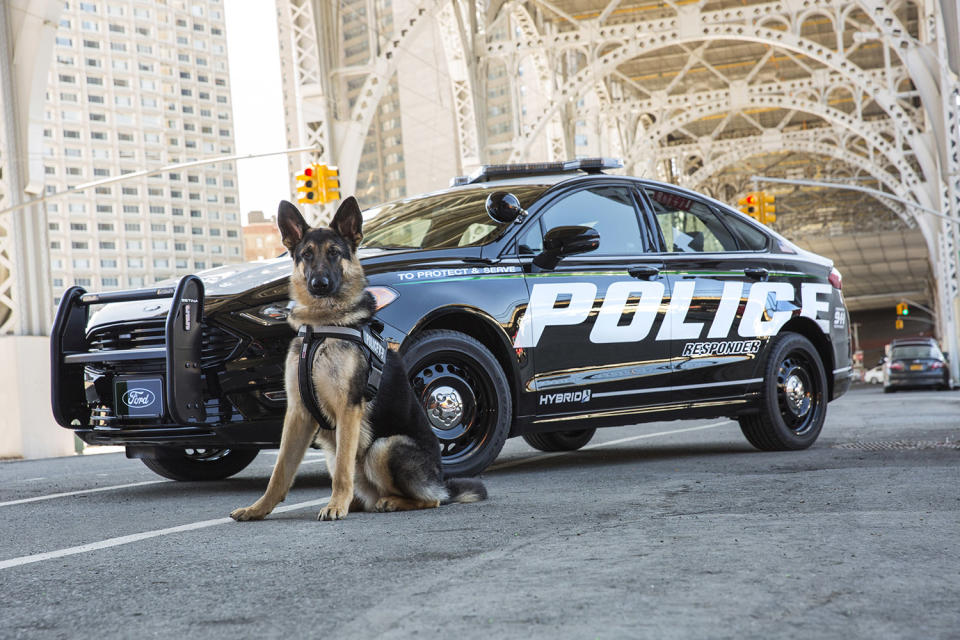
[50,276,285,448]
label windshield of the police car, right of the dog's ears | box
[361,184,549,249]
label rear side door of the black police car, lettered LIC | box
[643,185,772,402]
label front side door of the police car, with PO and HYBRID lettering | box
[514,182,670,423]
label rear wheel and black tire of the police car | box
[740,332,829,451]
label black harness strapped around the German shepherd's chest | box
[297,324,387,431]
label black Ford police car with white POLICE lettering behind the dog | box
[51,159,851,480]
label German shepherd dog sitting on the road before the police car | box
[230,196,487,520]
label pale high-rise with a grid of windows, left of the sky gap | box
[43,0,243,304]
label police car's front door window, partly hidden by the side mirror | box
[536,186,648,256]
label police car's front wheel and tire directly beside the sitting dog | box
[403,330,513,476]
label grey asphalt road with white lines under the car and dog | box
[0,387,960,640]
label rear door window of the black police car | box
[644,187,738,253]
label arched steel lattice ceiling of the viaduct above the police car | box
[476,0,939,308]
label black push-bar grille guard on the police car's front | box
[50,275,206,429]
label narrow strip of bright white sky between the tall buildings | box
[224,0,290,222]
